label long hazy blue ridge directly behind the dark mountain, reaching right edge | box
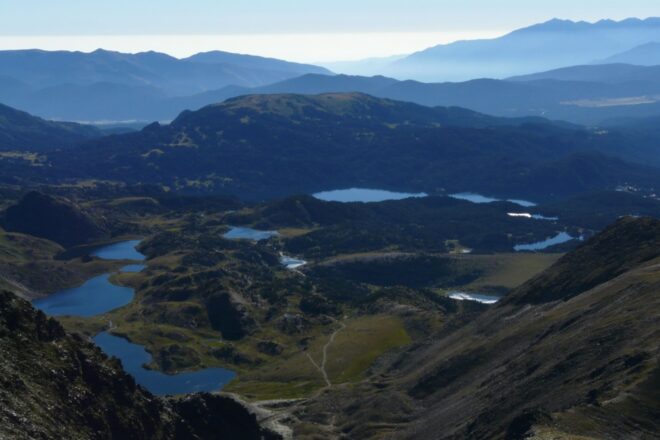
[173,64,660,125]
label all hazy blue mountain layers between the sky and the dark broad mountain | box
[0,18,660,125]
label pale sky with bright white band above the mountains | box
[0,0,660,62]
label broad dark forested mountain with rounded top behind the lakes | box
[0,93,660,200]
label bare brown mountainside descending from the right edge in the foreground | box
[296,218,660,440]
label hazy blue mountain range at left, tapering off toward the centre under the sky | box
[0,49,331,121]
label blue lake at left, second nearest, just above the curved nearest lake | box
[32,274,134,317]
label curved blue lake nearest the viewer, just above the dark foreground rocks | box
[94,332,236,395]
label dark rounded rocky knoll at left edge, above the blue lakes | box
[0,191,105,247]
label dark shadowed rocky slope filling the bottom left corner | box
[0,292,278,440]
